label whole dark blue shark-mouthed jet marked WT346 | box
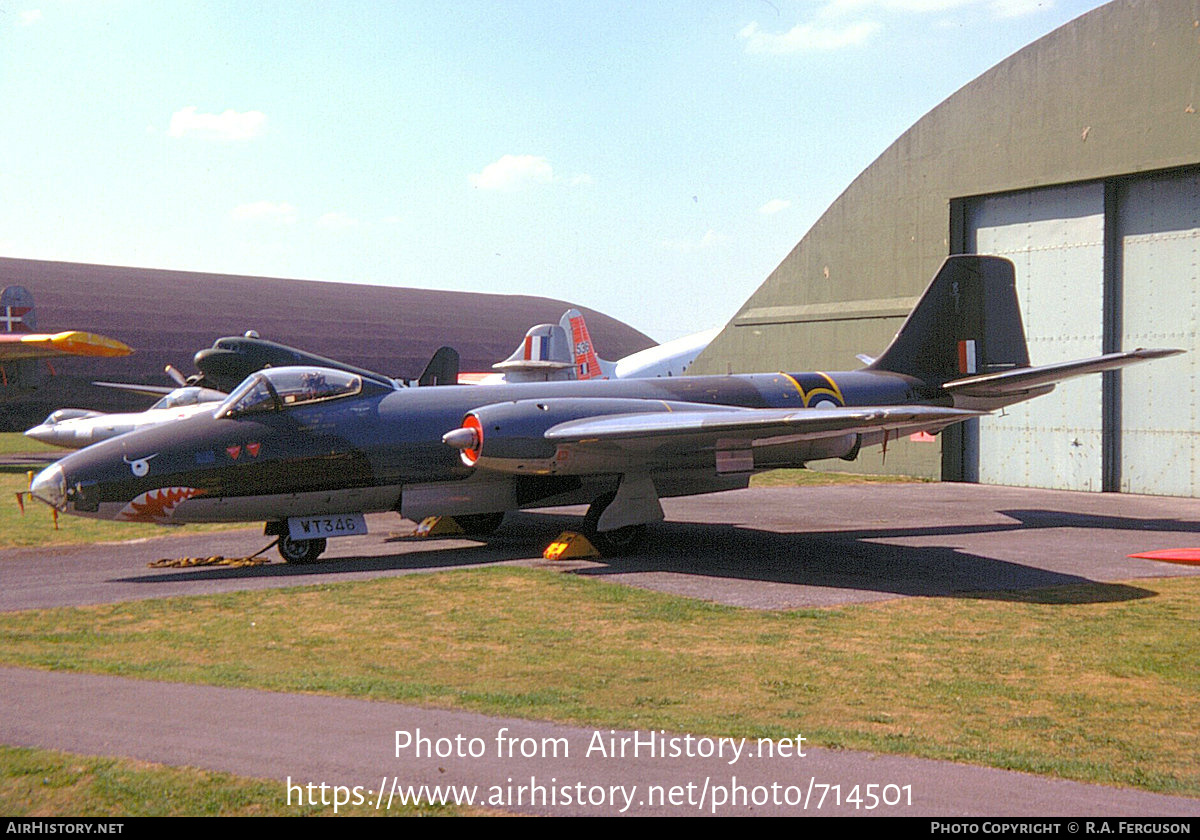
[30,256,1180,562]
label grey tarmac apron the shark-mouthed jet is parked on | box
[0,484,1200,610]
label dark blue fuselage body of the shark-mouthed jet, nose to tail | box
[35,371,916,521]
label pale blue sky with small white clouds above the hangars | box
[0,0,1102,340]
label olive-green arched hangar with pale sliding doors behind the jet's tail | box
[694,0,1200,496]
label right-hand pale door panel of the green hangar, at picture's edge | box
[1118,172,1200,496]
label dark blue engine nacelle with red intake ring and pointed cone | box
[442,398,709,475]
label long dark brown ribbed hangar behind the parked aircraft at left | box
[0,258,654,431]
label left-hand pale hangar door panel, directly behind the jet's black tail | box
[965,182,1104,491]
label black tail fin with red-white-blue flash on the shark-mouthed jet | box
[869,254,1030,385]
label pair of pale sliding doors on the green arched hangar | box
[959,167,1200,496]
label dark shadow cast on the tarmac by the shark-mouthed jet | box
[114,510,1200,604]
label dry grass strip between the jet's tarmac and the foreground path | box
[0,568,1200,797]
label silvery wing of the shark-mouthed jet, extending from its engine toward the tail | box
[545,406,985,451]
